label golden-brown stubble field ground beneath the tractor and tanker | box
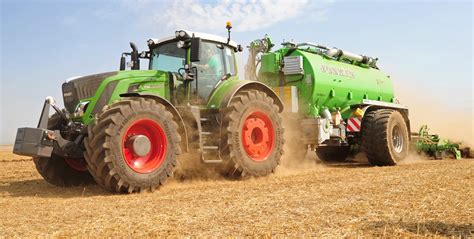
[0,148,474,238]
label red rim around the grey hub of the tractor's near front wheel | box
[122,119,167,173]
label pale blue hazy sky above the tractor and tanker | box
[0,0,474,144]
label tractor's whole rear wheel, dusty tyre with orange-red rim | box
[222,90,284,176]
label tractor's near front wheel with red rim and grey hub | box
[85,97,181,193]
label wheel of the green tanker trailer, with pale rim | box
[361,109,409,166]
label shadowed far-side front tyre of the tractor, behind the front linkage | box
[33,113,94,187]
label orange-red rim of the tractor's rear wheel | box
[242,111,275,162]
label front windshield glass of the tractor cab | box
[150,41,186,72]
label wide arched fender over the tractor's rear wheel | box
[208,80,284,113]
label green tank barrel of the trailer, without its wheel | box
[258,43,395,119]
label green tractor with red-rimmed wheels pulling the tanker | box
[14,24,284,193]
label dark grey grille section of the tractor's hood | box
[62,71,118,112]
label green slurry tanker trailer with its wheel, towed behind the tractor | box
[246,36,410,166]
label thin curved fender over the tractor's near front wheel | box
[120,92,189,152]
